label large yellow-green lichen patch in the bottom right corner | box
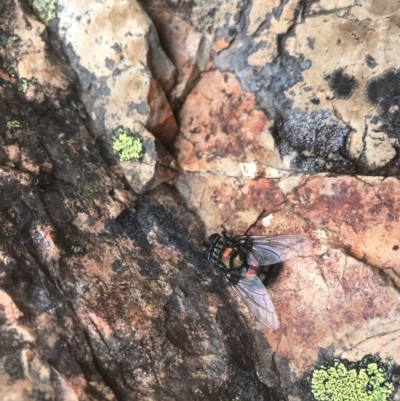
[310,356,394,401]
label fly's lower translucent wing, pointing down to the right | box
[224,275,279,330]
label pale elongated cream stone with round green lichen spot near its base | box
[50,1,177,192]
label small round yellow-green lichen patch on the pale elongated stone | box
[112,127,143,162]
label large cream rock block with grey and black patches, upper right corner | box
[168,0,399,175]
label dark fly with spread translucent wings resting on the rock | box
[203,233,312,330]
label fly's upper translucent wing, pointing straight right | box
[235,235,312,266]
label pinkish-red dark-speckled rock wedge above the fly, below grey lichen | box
[174,71,282,178]
